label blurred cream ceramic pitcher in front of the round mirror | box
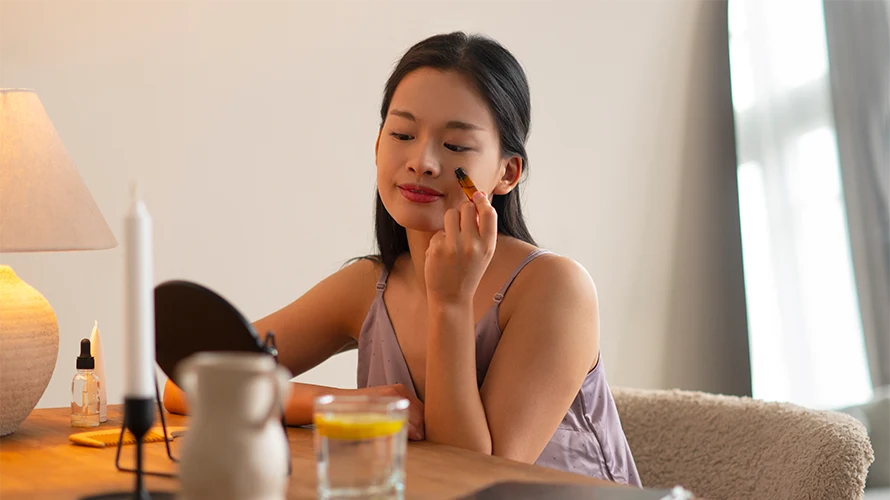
[177,352,291,500]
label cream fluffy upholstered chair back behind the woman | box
[612,387,874,500]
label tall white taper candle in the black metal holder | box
[124,184,155,398]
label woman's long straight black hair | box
[374,32,535,271]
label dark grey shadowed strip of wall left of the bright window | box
[662,2,751,395]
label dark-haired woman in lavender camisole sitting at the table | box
[164,33,640,486]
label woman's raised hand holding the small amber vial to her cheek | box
[424,191,498,304]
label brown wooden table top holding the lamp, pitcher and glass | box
[0,406,624,500]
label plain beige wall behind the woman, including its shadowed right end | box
[0,0,749,406]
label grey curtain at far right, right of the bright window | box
[824,0,890,387]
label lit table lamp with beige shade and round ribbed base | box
[0,89,117,436]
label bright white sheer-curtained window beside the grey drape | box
[729,0,876,409]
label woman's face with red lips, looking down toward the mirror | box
[377,68,522,232]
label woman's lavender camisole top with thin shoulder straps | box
[358,249,641,486]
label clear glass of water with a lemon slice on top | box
[313,396,408,499]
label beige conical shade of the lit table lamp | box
[0,89,117,253]
